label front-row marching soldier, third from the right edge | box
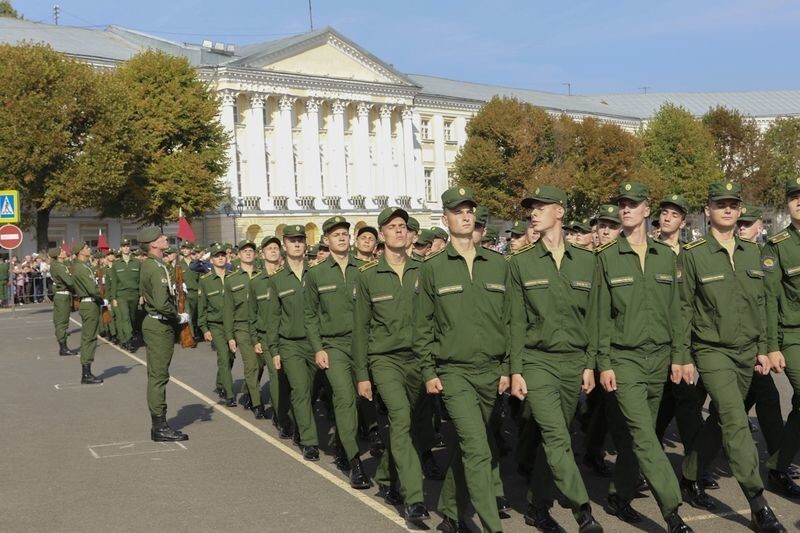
[588,182,694,533]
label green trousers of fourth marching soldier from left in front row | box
[282,339,319,446]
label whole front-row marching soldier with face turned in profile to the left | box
[506,186,603,533]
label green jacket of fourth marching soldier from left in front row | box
[265,263,308,357]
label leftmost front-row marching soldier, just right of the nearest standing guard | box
[197,244,236,407]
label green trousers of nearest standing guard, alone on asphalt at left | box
[142,316,175,416]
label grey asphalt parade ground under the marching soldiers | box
[0,304,800,533]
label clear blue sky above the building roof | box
[7,0,800,94]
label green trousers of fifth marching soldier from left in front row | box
[324,338,360,460]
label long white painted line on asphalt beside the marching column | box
[70,317,413,531]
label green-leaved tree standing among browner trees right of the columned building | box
[640,103,723,207]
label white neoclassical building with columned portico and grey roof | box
[0,18,800,251]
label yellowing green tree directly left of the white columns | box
[106,51,228,225]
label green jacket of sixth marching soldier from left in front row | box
[353,256,422,381]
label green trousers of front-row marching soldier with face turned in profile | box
[522,353,589,513]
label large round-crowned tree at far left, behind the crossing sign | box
[0,44,125,249]
